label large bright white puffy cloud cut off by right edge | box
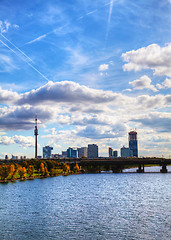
[122,43,171,77]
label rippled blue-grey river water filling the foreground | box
[0,167,171,240]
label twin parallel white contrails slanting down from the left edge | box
[0,36,50,82]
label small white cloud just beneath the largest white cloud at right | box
[129,75,158,92]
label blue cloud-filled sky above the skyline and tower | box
[0,0,171,158]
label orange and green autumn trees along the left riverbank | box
[0,159,80,183]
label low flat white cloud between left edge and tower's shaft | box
[0,135,34,147]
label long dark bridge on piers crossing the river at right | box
[62,157,171,173]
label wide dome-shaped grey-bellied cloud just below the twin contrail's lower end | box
[18,81,119,105]
